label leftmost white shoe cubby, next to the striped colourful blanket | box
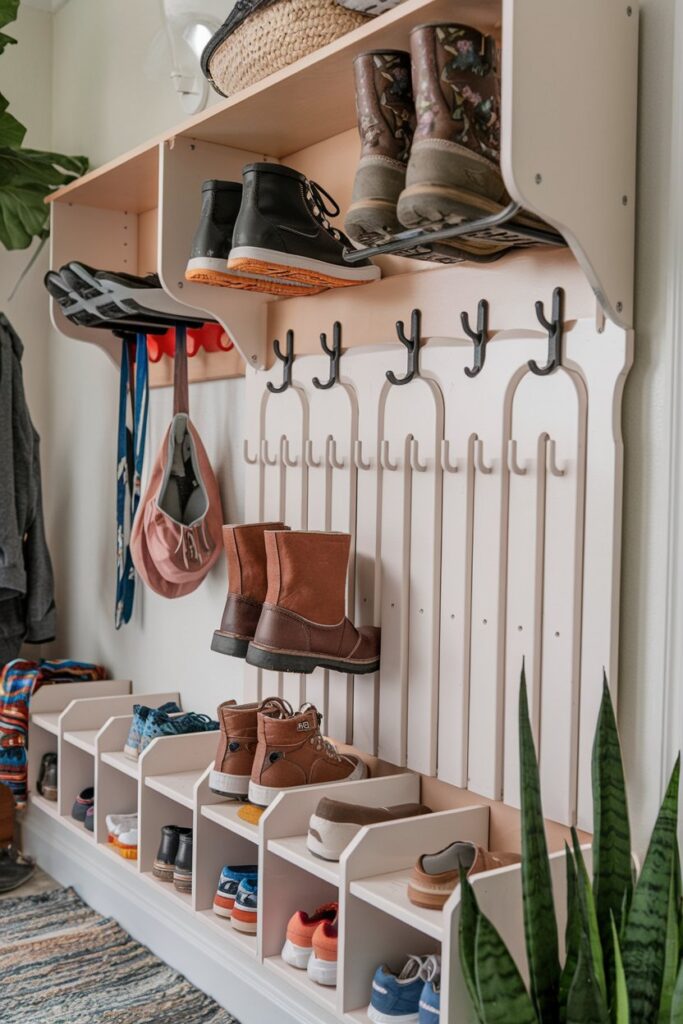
[28,679,131,817]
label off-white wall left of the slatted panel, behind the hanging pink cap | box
[45,0,244,714]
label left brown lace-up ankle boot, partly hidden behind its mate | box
[209,697,292,800]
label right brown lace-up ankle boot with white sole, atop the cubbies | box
[249,705,368,807]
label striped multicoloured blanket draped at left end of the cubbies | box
[0,658,106,807]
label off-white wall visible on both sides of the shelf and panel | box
[0,0,683,845]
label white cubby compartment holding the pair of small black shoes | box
[137,731,218,909]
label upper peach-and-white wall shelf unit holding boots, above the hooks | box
[51,0,638,380]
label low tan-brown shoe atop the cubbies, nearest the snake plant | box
[408,843,521,910]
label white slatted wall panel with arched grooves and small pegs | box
[245,321,630,824]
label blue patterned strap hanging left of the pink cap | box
[114,334,150,630]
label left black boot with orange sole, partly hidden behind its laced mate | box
[185,180,317,297]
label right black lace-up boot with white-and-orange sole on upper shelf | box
[227,164,381,291]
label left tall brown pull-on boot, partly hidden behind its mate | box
[211,522,287,657]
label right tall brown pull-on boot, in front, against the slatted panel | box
[247,530,380,676]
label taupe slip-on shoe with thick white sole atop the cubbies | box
[306,797,431,860]
